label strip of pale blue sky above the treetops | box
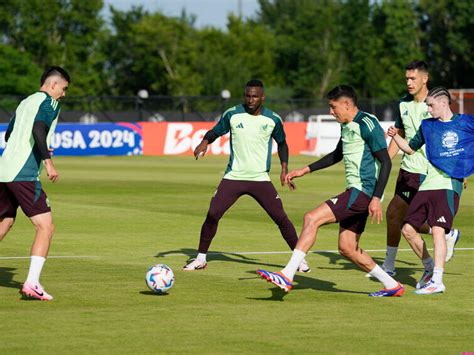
[104,0,259,29]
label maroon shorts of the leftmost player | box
[0,181,51,218]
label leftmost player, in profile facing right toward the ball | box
[0,67,71,301]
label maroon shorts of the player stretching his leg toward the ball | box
[326,187,370,234]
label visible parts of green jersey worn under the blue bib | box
[409,115,463,196]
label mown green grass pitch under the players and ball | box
[0,157,474,354]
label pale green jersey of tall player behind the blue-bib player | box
[395,95,430,175]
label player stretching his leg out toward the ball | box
[257,85,404,297]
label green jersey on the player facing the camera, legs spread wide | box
[212,105,286,181]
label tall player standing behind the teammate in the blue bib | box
[378,60,460,276]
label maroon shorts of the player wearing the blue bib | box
[404,190,459,233]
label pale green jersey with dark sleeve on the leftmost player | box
[0,92,59,182]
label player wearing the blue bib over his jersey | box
[388,87,474,294]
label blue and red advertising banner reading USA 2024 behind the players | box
[0,121,393,156]
